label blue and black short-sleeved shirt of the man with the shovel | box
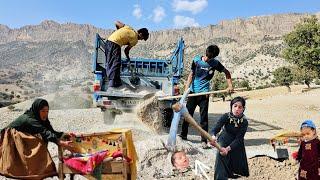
[191,55,225,93]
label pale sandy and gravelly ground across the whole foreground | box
[0,86,320,180]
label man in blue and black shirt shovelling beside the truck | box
[180,45,233,148]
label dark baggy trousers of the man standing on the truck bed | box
[105,41,122,87]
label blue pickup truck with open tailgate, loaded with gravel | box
[92,34,185,124]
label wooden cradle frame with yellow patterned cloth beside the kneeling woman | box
[58,132,131,180]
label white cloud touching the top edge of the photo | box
[172,0,208,14]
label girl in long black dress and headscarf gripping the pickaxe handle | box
[211,97,249,180]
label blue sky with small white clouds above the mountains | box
[0,0,320,31]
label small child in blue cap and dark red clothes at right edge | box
[297,120,320,180]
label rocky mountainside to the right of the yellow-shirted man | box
[137,13,320,87]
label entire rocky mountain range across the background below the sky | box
[0,13,320,100]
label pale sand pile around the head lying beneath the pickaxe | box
[135,135,216,180]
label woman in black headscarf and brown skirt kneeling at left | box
[0,99,71,179]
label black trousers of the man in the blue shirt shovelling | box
[181,95,209,142]
